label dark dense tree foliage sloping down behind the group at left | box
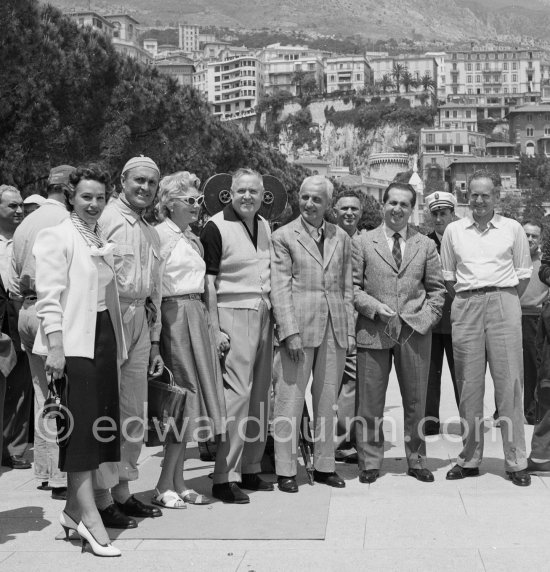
[0,0,305,204]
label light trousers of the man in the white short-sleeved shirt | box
[451,288,527,472]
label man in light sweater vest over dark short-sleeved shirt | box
[201,169,273,504]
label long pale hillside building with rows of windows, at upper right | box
[445,49,542,101]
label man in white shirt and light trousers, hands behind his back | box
[441,171,533,486]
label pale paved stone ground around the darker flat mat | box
[0,362,550,572]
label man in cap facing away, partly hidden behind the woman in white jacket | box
[9,165,75,492]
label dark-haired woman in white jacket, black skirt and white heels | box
[33,166,126,556]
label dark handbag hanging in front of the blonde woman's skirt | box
[145,366,187,447]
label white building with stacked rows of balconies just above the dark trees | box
[193,55,260,119]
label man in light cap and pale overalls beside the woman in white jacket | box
[94,156,164,528]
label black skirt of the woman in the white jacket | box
[59,310,120,472]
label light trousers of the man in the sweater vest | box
[213,302,273,484]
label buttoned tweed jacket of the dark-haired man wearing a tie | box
[353,225,445,349]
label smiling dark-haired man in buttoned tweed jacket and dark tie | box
[353,183,445,483]
